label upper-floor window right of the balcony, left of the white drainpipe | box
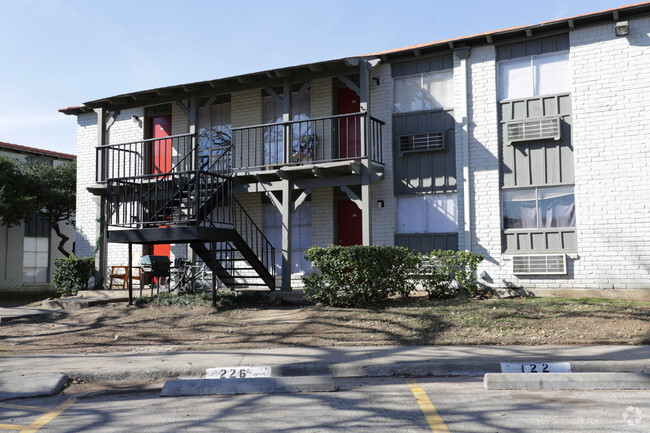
[394,69,454,113]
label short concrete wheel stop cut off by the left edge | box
[0,374,68,400]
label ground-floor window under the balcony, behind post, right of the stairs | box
[264,201,312,274]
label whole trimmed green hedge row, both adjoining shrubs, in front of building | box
[303,245,483,307]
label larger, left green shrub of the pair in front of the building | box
[303,245,419,307]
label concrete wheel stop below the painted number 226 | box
[160,376,336,397]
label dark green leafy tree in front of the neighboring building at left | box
[0,157,77,257]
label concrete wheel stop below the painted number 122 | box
[483,372,650,390]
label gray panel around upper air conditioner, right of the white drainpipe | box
[499,94,574,187]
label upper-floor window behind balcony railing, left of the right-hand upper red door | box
[264,91,312,164]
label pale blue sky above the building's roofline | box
[0,0,640,154]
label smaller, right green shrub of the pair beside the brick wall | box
[421,250,483,299]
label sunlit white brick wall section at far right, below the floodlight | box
[570,18,650,289]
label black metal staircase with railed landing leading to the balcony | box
[103,138,275,290]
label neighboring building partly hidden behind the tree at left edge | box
[0,142,76,297]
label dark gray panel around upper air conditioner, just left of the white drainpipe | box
[393,110,457,196]
